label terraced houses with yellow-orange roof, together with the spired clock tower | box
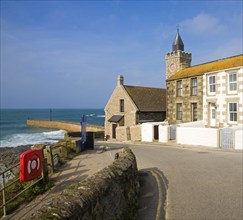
[165,28,243,127]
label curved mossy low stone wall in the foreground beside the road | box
[27,147,139,220]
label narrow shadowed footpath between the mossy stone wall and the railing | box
[4,145,118,220]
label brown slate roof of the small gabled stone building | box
[124,85,166,112]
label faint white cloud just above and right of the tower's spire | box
[180,13,225,35]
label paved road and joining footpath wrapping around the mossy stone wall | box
[2,142,243,220]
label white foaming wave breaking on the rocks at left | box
[0,130,65,147]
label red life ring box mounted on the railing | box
[19,150,42,182]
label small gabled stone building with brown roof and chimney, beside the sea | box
[104,76,166,140]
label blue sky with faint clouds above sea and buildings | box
[0,0,243,108]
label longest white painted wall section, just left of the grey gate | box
[176,127,218,148]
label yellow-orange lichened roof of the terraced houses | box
[167,54,243,81]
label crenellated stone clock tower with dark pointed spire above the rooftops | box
[165,28,192,79]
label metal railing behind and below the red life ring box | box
[0,163,43,217]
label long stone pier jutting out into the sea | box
[27,119,104,132]
